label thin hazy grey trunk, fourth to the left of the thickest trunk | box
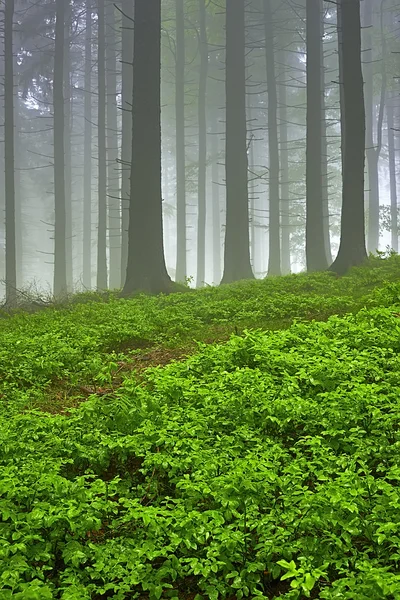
[82,0,92,289]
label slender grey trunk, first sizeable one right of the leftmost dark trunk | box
[53,0,67,297]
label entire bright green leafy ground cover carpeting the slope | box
[0,251,400,600]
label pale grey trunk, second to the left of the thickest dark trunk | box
[106,0,121,289]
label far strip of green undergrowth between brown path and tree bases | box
[0,255,400,411]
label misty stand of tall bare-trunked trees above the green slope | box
[0,0,400,305]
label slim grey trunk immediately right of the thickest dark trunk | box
[175,0,187,282]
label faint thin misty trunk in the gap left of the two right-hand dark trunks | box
[278,50,290,275]
